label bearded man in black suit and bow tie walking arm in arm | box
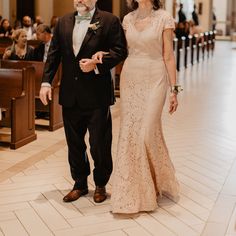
[40,0,127,203]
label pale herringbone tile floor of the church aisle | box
[0,42,236,236]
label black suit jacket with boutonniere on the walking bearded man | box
[42,9,127,109]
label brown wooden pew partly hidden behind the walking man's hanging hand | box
[0,60,63,131]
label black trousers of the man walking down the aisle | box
[62,107,112,189]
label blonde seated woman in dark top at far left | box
[3,29,34,61]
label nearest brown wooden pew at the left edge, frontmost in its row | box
[0,67,36,149]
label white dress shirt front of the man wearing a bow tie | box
[72,8,95,56]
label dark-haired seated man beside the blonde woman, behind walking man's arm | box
[34,24,52,62]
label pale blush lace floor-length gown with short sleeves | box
[111,9,179,213]
